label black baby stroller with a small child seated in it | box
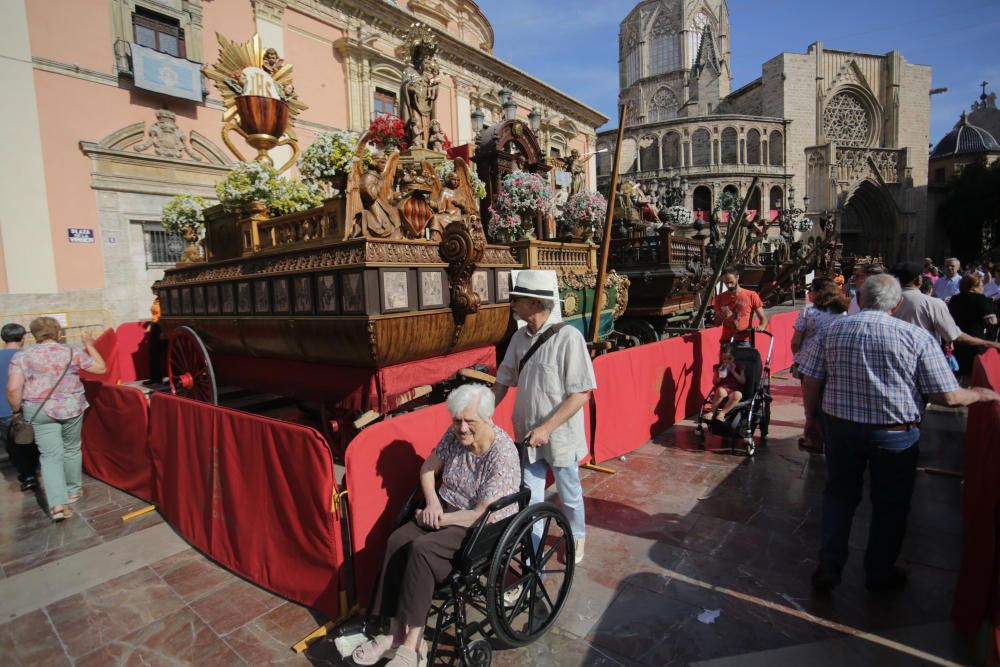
[695,329,774,456]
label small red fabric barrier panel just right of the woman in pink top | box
[83,380,156,503]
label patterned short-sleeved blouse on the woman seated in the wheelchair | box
[434,425,521,521]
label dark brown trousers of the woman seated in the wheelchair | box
[372,521,469,627]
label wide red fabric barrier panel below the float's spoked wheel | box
[150,394,343,618]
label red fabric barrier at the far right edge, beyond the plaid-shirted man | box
[952,350,1000,649]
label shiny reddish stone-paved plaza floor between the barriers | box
[0,377,974,667]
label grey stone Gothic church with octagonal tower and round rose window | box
[597,0,931,262]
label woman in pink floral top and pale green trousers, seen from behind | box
[7,317,107,521]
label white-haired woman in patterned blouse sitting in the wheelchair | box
[352,384,521,667]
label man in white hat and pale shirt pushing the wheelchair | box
[493,271,597,563]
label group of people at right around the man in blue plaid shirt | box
[792,258,1000,591]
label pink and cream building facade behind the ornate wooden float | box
[0,0,608,328]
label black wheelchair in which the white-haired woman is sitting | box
[368,443,576,667]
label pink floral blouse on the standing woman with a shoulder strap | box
[8,343,94,419]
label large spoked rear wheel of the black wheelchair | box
[486,503,576,647]
